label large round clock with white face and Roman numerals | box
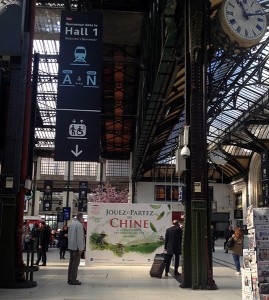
[220,0,267,46]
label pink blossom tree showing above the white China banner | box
[91,183,128,203]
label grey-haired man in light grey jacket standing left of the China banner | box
[67,213,85,285]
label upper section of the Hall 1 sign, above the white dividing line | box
[57,11,103,111]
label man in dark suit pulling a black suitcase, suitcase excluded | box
[164,220,182,276]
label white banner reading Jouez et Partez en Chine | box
[86,203,172,264]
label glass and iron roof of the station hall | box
[0,0,269,182]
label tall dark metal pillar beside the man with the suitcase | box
[181,0,217,289]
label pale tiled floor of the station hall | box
[0,240,242,300]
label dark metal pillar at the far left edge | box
[0,1,36,288]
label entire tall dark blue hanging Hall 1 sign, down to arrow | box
[54,11,103,161]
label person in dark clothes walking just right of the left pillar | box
[36,221,50,266]
